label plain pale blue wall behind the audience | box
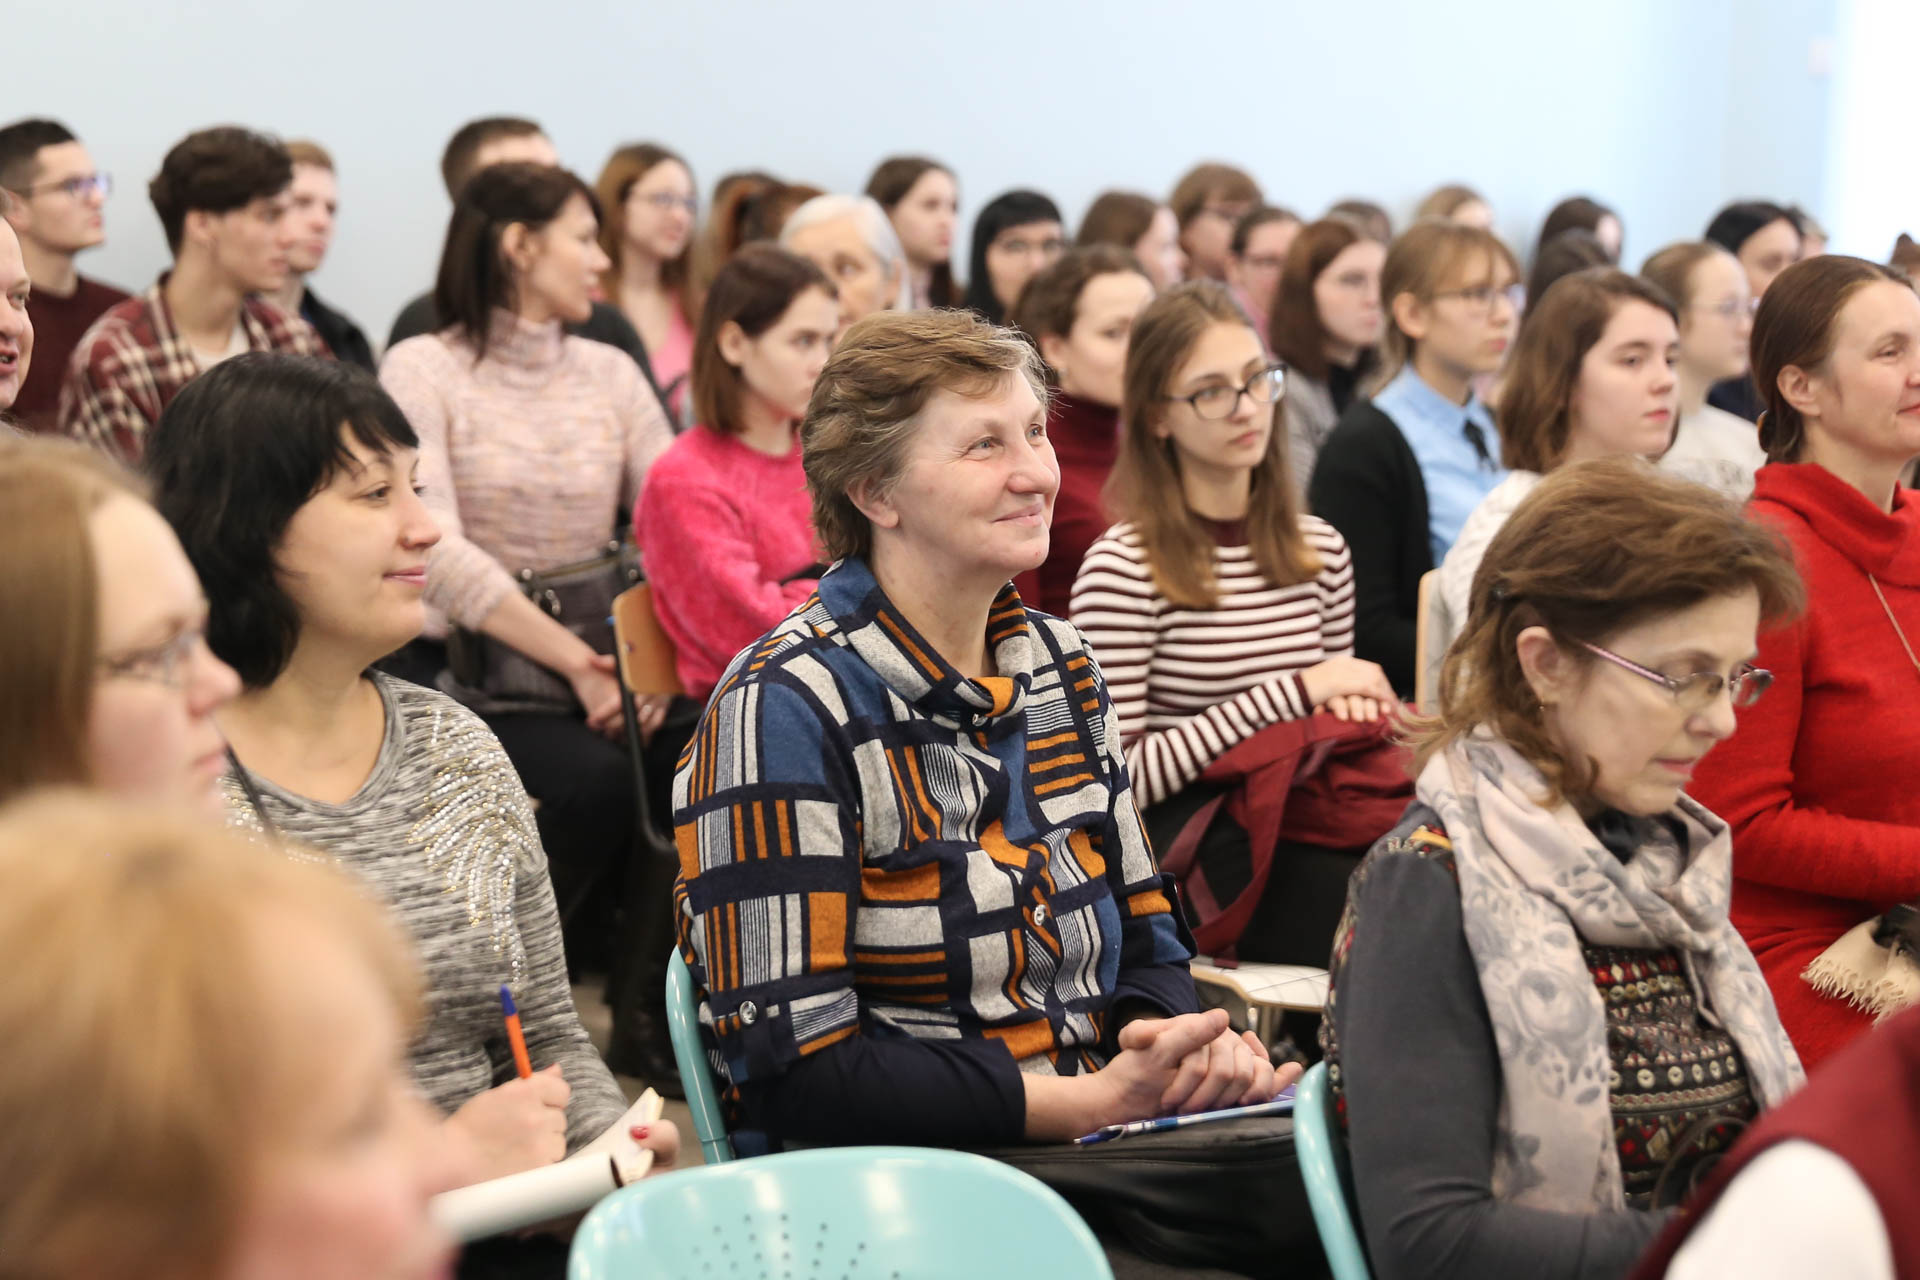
[11,0,1837,342]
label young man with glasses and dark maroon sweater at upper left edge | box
[0,119,127,432]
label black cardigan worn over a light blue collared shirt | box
[1308,401,1434,697]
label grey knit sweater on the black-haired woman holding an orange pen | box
[223,672,626,1151]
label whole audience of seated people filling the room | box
[0,102,1920,1280]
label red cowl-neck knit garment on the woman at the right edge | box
[1692,462,1920,1071]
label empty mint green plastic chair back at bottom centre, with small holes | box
[566,1148,1114,1280]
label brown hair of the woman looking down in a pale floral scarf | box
[1407,457,1807,804]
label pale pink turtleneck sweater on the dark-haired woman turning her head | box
[380,311,674,633]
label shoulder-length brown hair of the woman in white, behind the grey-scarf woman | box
[1500,267,1680,476]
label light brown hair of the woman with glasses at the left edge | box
[0,436,144,802]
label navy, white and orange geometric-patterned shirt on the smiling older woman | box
[674,558,1196,1084]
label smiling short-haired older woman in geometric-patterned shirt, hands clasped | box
[674,311,1277,1146]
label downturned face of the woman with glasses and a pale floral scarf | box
[1517,587,1761,816]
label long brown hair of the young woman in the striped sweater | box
[1106,280,1321,608]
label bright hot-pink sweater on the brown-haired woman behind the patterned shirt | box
[634,426,820,700]
